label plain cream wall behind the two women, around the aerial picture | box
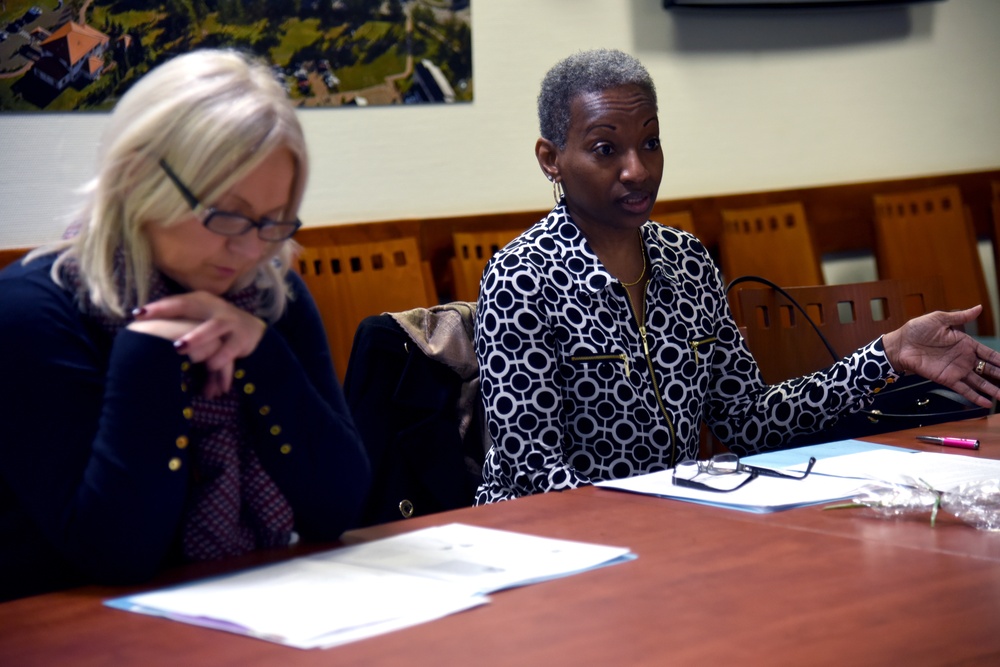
[0,0,1000,247]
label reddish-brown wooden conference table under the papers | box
[0,415,1000,667]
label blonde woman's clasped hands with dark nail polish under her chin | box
[128,292,267,398]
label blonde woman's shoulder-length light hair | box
[39,50,308,320]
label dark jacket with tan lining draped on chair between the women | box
[344,302,487,525]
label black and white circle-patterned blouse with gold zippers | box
[475,204,897,504]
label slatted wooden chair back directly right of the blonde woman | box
[298,237,437,381]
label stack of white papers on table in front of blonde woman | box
[105,524,634,648]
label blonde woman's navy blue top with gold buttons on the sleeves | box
[0,257,371,600]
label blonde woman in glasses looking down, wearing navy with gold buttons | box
[0,50,370,600]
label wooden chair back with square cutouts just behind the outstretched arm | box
[738,276,944,384]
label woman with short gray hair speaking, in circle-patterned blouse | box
[475,50,1000,504]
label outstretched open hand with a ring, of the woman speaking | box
[882,306,1000,408]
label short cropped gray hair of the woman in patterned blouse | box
[538,49,656,150]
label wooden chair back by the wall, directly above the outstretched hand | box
[874,186,995,336]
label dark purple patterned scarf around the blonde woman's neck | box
[61,260,293,560]
